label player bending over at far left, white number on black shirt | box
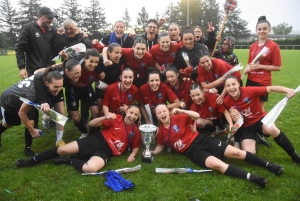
[0,68,63,156]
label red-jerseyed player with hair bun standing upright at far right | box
[245,16,281,109]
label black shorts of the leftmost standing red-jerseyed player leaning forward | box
[65,85,98,111]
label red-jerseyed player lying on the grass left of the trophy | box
[16,105,140,172]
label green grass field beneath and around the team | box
[0,50,300,201]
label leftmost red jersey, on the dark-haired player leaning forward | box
[70,63,99,88]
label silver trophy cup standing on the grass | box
[139,124,157,163]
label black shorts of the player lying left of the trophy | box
[76,133,112,164]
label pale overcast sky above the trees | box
[11,0,300,34]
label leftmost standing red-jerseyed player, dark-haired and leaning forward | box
[65,49,100,137]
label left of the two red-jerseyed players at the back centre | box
[103,37,155,88]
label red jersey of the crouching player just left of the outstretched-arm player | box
[191,93,226,120]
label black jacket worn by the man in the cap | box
[15,22,57,75]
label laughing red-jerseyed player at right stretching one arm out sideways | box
[224,76,300,163]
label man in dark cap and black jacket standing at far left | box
[16,7,57,156]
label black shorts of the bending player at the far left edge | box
[1,106,36,126]
